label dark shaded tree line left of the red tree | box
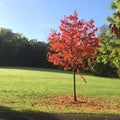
[0,28,50,67]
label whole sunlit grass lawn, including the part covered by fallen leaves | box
[0,68,120,114]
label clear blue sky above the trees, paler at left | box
[0,0,113,42]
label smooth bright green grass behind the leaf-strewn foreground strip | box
[0,68,120,98]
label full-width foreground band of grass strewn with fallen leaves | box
[0,95,120,114]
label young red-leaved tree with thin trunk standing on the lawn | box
[48,11,100,101]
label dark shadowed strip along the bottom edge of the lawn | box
[0,106,120,120]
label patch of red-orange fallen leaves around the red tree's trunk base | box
[30,95,120,114]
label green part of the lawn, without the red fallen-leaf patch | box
[0,68,120,113]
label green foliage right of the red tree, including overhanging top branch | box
[89,0,120,77]
